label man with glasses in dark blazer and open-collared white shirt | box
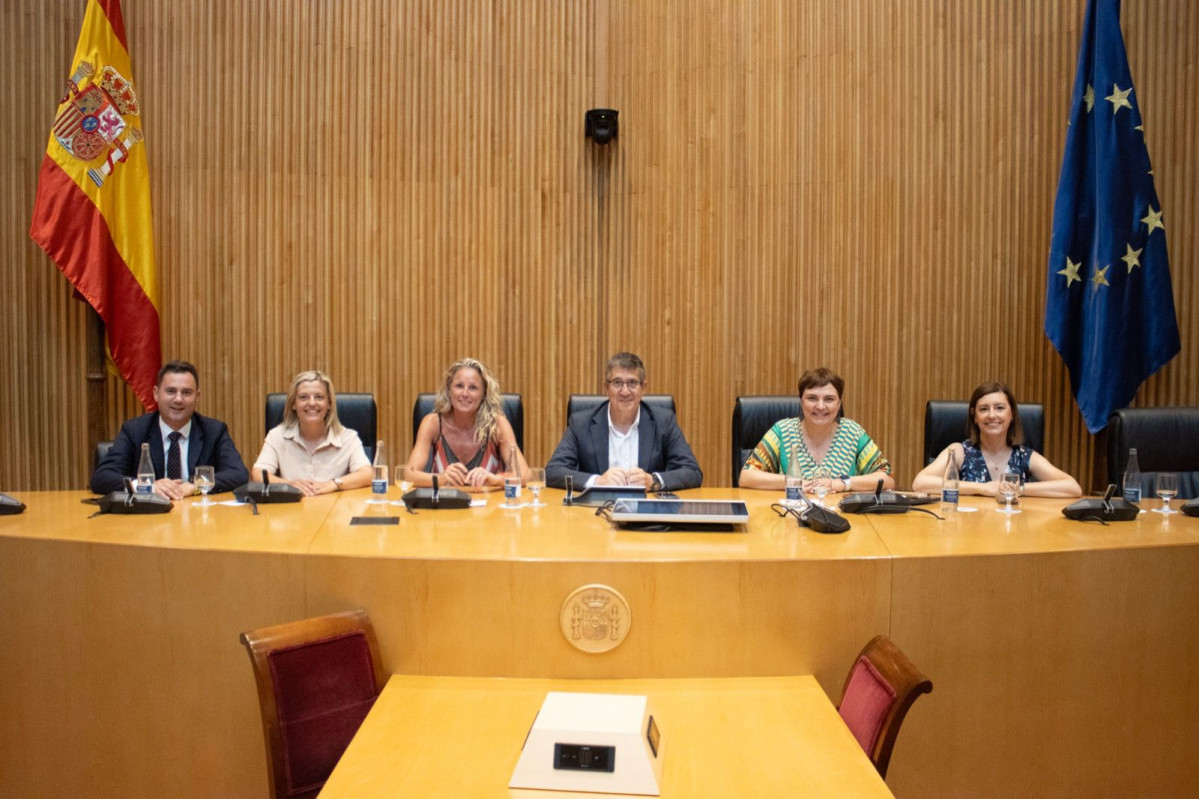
[546,353,704,491]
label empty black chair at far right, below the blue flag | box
[1108,408,1199,499]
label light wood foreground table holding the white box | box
[320,675,891,799]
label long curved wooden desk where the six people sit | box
[0,488,1199,797]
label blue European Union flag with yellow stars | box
[1046,0,1181,433]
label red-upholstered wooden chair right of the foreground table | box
[837,636,933,779]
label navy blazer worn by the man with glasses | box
[546,402,704,491]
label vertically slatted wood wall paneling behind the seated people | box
[0,0,1199,491]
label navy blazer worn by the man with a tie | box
[91,411,249,494]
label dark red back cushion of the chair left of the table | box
[267,631,378,794]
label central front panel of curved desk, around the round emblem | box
[306,558,891,676]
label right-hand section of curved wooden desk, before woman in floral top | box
[878,500,1199,797]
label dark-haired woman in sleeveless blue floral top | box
[911,383,1083,497]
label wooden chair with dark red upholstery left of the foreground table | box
[233,609,387,799]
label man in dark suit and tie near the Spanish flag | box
[91,361,249,499]
